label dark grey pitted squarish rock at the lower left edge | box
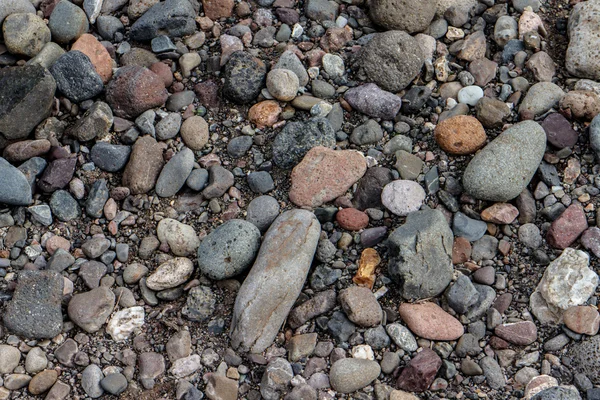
[0,271,64,340]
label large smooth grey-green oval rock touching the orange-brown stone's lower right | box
[463,121,546,201]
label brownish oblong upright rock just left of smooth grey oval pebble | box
[122,136,163,194]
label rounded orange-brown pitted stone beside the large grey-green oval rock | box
[435,115,487,155]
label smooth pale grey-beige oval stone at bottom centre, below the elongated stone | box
[329,358,381,393]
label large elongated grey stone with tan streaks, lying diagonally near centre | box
[231,210,321,353]
